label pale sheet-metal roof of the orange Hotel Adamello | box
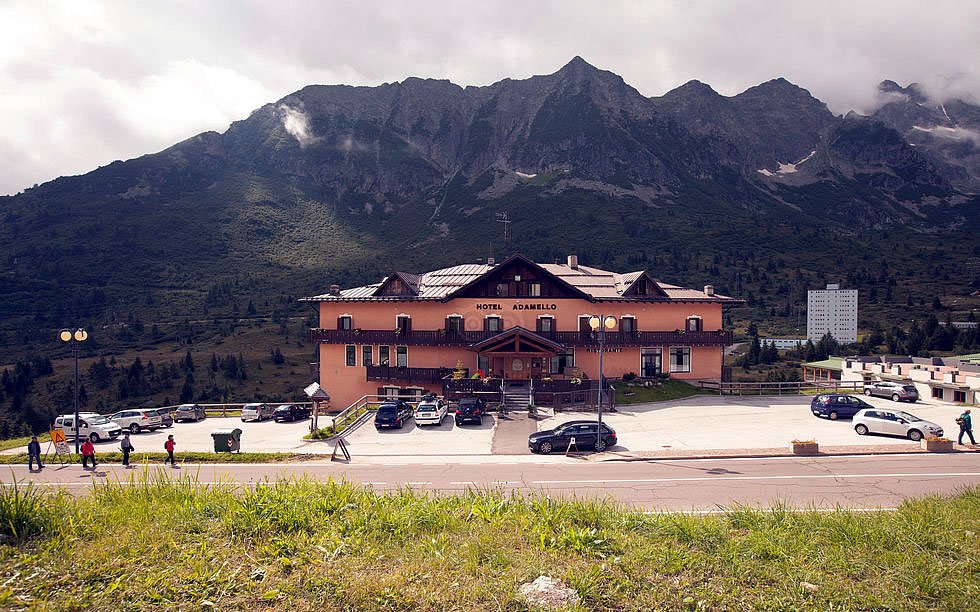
[301,255,743,304]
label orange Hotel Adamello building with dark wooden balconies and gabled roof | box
[303,255,743,409]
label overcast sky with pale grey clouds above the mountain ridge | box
[0,0,980,194]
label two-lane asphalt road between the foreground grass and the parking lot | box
[9,453,980,511]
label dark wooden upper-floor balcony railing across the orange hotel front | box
[310,329,733,347]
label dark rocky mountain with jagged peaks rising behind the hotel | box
[0,57,980,364]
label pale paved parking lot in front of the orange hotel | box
[17,395,963,456]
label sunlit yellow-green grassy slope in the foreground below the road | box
[0,479,980,610]
